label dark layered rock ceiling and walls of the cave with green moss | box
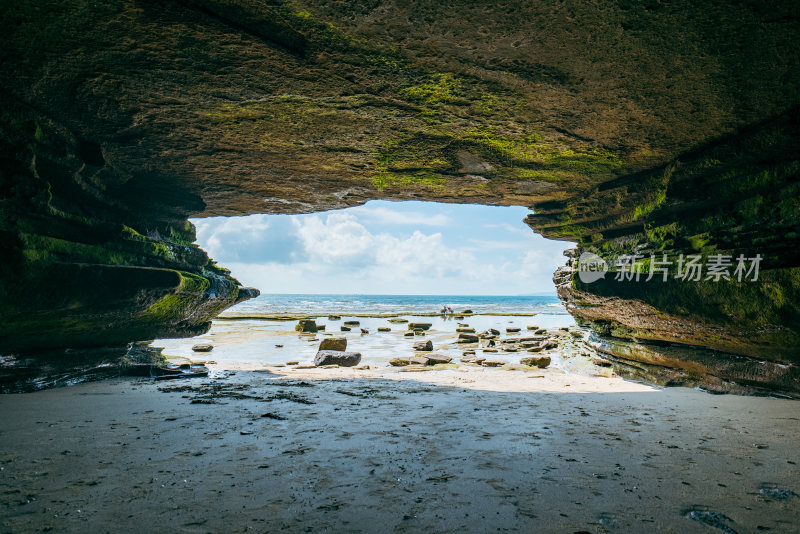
[0,0,800,394]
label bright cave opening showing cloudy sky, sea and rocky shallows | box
[155,200,575,367]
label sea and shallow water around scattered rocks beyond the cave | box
[154,295,575,368]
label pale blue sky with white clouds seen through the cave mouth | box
[192,200,571,295]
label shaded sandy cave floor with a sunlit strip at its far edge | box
[0,366,800,532]
